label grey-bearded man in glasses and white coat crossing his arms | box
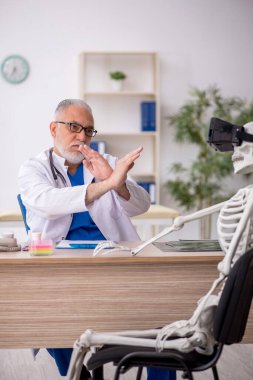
[18,99,150,379]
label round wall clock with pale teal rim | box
[1,55,30,84]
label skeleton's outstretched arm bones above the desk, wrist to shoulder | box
[131,202,225,256]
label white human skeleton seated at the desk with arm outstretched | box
[68,122,253,380]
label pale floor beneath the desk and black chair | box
[0,344,253,380]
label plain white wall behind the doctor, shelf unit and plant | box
[0,0,253,238]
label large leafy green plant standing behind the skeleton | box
[165,86,253,239]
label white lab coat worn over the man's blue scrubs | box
[18,149,150,242]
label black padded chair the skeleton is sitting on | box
[87,249,253,380]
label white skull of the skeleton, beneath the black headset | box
[232,122,253,174]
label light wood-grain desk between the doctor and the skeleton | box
[0,243,253,348]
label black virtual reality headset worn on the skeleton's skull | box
[207,117,253,152]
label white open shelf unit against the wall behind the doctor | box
[79,52,160,203]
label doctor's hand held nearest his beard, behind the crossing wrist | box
[79,145,113,181]
